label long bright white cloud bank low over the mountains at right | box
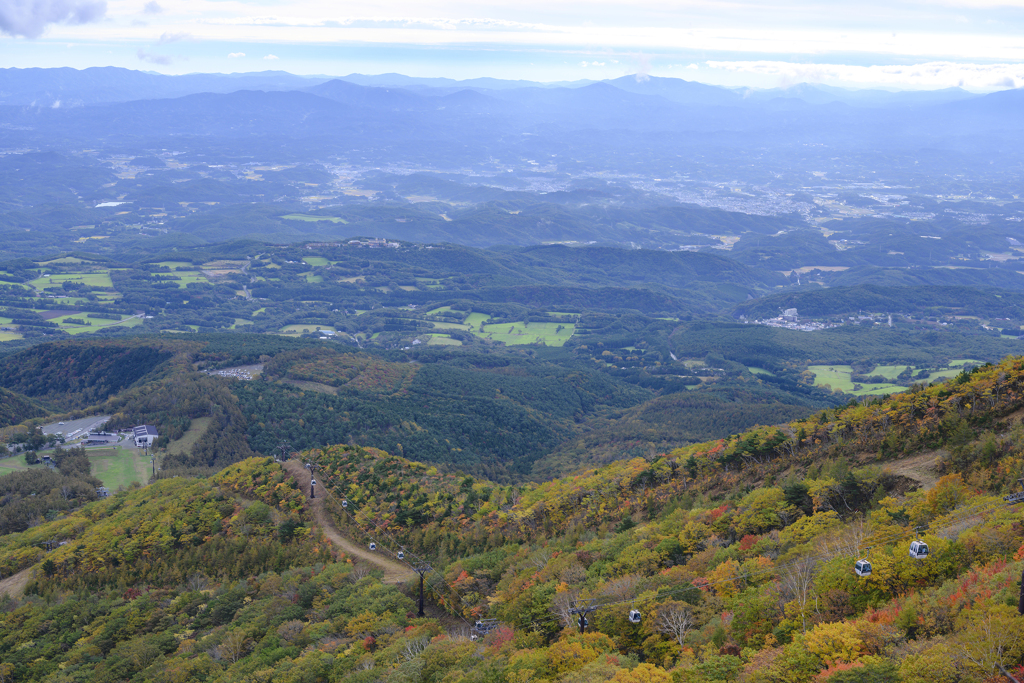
[708,60,1024,90]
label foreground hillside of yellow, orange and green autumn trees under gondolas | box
[0,358,1024,683]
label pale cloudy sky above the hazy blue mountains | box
[0,0,1024,92]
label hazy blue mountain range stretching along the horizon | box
[0,69,1024,163]
